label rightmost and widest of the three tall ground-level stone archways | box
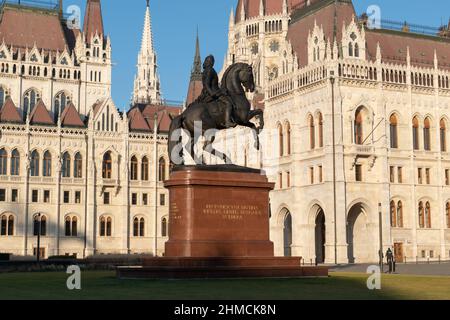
[347,203,374,263]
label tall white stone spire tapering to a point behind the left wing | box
[133,0,161,104]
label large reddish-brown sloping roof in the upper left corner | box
[0,5,74,51]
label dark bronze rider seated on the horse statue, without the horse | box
[195,55,237,128]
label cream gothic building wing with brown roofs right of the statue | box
[225,0,450,263]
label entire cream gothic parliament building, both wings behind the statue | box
[0,0,450,264]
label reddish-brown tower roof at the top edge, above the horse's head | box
[235,0,306,22]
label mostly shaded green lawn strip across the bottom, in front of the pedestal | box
[0,271,450,300]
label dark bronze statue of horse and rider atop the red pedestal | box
[169,55,264,164]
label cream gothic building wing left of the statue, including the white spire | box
[0,0,180,257]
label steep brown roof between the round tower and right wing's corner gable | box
[287,0,355,67]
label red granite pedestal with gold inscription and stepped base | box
[117,165,328,278]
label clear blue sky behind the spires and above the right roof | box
[64,0,450,109]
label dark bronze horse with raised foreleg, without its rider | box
[169,63,264,164]
